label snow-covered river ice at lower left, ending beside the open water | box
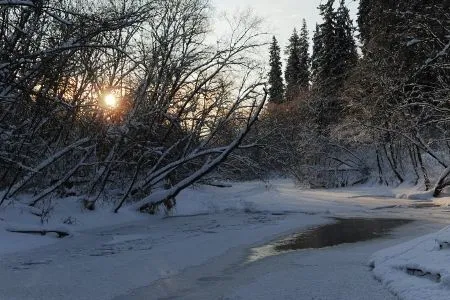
[0,192,328,299]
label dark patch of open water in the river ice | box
[248,218,412,262]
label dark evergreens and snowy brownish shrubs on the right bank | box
[261,0,450,196]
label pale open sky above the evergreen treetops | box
[211,0,359,49]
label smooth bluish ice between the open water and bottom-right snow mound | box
[115,218,444,300]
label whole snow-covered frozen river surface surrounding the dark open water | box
[0,181,450,299]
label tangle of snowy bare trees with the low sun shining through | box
[0,0,266,212]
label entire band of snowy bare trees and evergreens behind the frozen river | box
[0,0,450,213]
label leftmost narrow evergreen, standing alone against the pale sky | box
[269,36,284,103]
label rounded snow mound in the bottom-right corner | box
[370,226,450,300]
